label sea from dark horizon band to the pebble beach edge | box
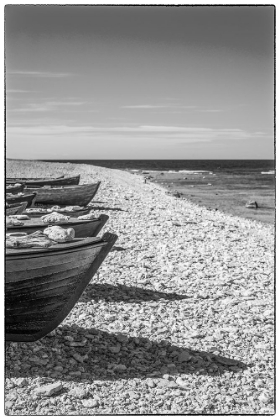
[46,159,276,224]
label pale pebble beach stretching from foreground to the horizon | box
[5,160,275,415]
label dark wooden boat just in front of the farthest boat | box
[24,182,100,206]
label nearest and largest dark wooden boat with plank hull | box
[5,233,117,341]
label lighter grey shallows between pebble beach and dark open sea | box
[130,170,275,225]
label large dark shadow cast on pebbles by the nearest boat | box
[6,324,248,387]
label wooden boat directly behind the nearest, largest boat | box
[7,214,109,238]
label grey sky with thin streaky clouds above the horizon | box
[5,5,274,160]
